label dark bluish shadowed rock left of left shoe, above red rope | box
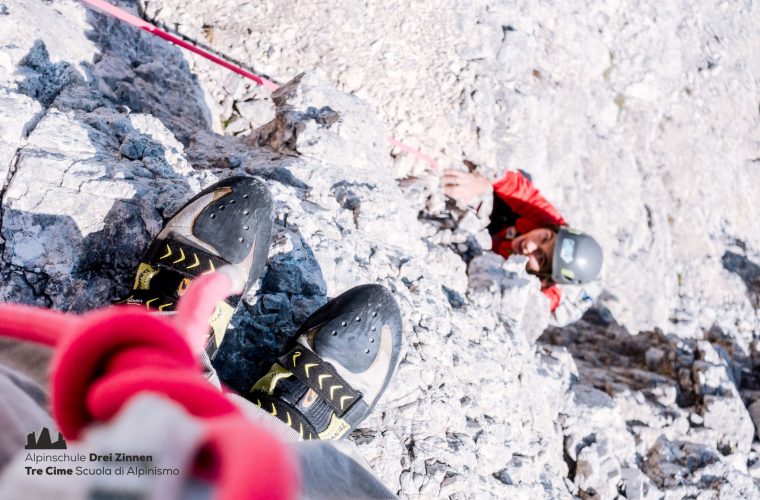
[0,200,150,312]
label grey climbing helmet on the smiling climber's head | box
[552,227,602,285]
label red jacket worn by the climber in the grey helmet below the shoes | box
[492,171,566,311]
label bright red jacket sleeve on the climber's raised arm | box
[493,171,565,226]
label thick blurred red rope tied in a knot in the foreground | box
[0,272,299,500]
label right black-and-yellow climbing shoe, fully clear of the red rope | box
[246,285,402,439]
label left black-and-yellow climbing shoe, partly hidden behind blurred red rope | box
[118,177,273,358]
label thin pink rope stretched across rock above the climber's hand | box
[82,0,440,173]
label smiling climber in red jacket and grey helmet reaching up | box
[443,170,602,319]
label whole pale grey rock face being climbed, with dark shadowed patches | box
[0,0,760,499]
